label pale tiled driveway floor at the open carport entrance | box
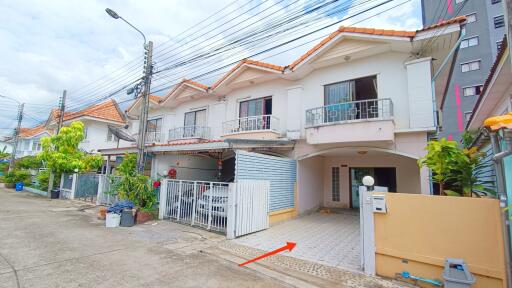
[233,210,361,270]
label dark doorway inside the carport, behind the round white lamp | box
[350,167,396,209]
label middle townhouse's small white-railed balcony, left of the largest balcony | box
[222,115,279,140]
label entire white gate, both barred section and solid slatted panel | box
[159,180,270,238]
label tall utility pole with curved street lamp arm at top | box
[105,8,153,173]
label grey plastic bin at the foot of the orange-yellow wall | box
[443,258,475,288]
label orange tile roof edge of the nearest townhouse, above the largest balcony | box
[288,16,466,70]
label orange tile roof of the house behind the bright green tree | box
[64,99,125,123]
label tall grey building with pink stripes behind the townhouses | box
[421,0,506,141]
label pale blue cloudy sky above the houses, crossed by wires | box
[0,0,422,136]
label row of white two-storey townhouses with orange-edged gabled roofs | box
[101,17,465,217]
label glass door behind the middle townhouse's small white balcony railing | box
[239,97,272,131]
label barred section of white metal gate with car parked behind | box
[160,180,230,232]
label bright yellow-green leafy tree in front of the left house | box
[37,121,103,174]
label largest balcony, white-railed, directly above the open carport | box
[306,99,395,144]
